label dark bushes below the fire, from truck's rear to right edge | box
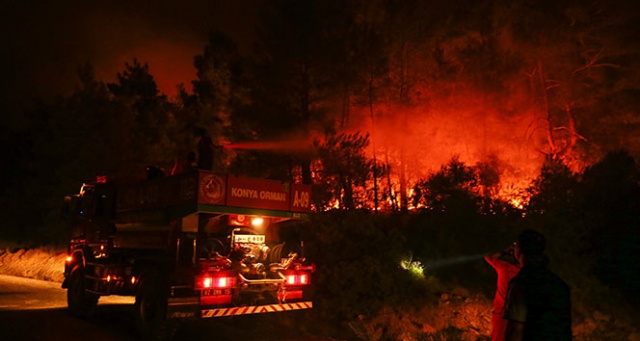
[308,148,640,326]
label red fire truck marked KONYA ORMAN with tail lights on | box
[62,170,315,334]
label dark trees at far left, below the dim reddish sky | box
[1,61,177,244]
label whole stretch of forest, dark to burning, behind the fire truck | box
[0,0,640,242]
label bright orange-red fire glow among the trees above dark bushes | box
[345,88,547,206]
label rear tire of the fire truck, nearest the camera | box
[135,275,177,341]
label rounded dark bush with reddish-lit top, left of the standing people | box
[404,158,522,293]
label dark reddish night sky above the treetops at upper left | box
[0,0,259,122]
